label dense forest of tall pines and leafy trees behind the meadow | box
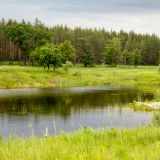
[0,19,160,67]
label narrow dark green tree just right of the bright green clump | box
[79,38,93,67]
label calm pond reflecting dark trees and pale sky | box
[0,86,154,137]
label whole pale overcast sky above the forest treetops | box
[0,0,160,35]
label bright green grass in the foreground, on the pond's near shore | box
[0,127,160,160]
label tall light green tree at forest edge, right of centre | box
[104,38,121,67]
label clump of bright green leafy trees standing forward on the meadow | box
[31,41,75,70]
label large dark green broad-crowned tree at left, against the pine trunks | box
[4,20,51,65]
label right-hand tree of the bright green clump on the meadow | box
[59,41,76,63]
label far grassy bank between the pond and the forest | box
[0,66,160,91]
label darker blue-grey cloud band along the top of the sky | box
[1,0,160,13]
